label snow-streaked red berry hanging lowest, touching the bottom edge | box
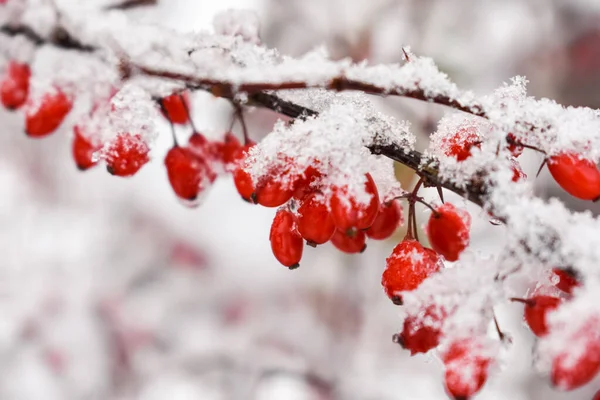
[442,339,491,400]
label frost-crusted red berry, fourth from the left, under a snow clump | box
[104,133,150,176]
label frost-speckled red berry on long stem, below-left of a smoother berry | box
[381,239,441,304]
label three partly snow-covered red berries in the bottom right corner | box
[511,268,600,390]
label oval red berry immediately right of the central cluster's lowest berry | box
[298,193,335,245]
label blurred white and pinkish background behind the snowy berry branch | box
[0,0,600,400]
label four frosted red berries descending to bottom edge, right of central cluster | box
[381,197,482,399]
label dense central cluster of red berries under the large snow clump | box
[258,170,403,269]
